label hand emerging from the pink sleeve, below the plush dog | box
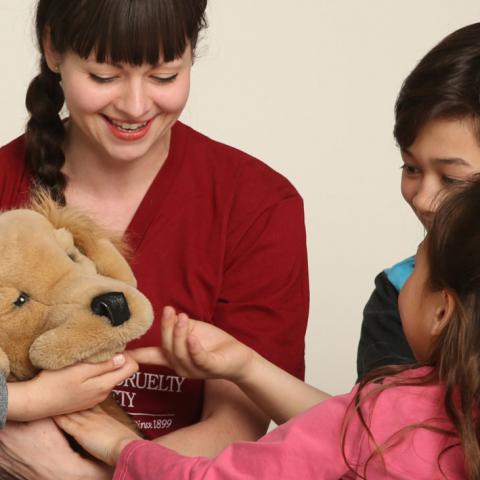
[54,407,141,465]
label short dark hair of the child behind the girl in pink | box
[394,23,480,149]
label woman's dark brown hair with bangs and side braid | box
[26,0,207,203]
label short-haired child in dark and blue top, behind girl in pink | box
[357,23,480,379]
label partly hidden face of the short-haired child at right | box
[402,118,480,231]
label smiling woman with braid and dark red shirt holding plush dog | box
[0,0,308,479]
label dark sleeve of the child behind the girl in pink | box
[357,272,415,380]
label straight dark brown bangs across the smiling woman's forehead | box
[41,0,207,65]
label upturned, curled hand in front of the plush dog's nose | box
[130,307,254,381]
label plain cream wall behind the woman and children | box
[0,0,480,393]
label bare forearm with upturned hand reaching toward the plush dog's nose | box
[131,307,329,424]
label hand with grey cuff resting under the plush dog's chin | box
[8,353,138,421]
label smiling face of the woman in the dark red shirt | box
[47,48,192,162]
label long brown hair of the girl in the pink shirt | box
[343,174,480,480]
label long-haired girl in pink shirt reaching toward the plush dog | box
[56,176,480,480]
